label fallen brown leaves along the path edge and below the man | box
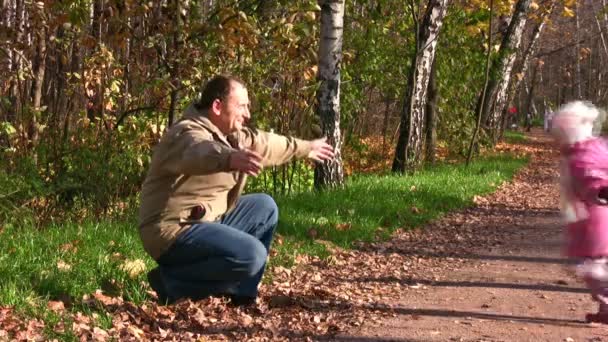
[0,130,556,341]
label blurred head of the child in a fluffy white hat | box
[551,101,602,145]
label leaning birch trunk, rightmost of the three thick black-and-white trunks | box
[478,0,531,138]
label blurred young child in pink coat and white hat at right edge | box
[551,101,608,324]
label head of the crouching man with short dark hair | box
[196,76,251,134]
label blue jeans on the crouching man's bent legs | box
[158,194,279,300]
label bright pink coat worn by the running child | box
[565,138,608,257]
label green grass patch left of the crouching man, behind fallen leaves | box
[0,221,153,340]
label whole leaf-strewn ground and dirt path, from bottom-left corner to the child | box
[0,131,608,342]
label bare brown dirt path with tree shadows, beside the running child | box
[338,132,608,342]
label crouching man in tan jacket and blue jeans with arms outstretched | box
[139,76,334,305]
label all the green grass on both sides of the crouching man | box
[0,155,526,340]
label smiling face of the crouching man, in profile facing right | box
[217,82,251,134]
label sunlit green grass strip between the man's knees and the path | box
[277,156,526,264]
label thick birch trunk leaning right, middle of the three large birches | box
[392,0,449,173]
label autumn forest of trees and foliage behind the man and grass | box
[0,0,608,226]
